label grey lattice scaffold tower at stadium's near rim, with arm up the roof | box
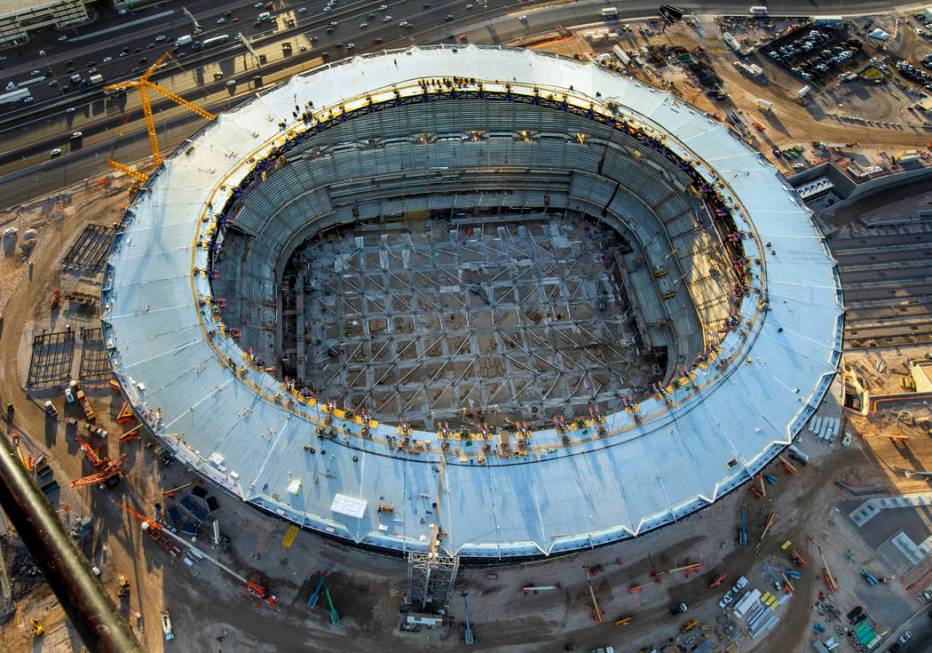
[406,454,460,612]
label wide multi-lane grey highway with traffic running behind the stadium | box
[0,0,920,207]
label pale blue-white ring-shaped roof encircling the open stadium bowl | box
[102,45,843,557]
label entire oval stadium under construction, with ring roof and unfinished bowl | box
[102,45,843,560]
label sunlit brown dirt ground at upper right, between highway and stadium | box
[548,16,932,174]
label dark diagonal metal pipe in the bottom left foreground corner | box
[0,428,143,653]
